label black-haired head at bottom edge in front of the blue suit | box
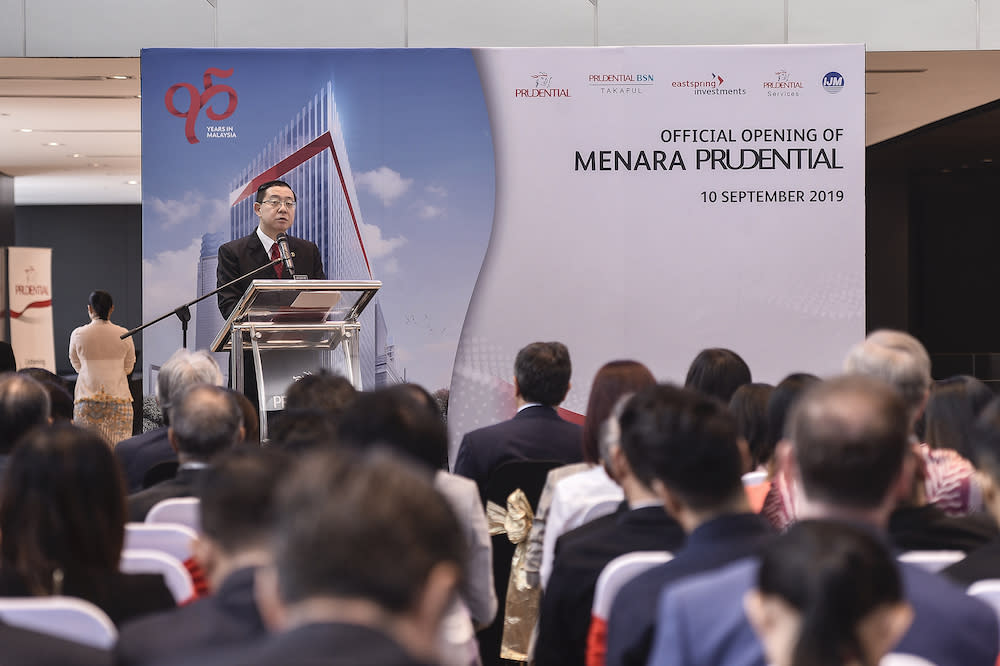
[743,520,913,666]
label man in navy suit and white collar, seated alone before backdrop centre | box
[455,342,583,497]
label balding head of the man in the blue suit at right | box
[788,375,909,509]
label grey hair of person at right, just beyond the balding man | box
[844,329,931,416]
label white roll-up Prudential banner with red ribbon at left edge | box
[7,247,56,372]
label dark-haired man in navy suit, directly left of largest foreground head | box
[115,449,291,666]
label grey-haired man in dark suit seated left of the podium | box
[115,349,222,493]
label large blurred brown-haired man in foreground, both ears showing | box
[166,449,464,666]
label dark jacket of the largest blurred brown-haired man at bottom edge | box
[156,623,436,666]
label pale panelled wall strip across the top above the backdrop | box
[0,0,1000,57]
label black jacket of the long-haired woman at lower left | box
[0,569,175,624]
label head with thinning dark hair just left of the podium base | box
[170,384,243,461]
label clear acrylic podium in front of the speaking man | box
[211,280,382,439]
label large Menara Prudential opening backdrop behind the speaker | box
[142,45,865,460]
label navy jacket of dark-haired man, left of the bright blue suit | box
[605,513,774,666]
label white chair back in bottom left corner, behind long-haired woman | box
[0,596,118,650]
